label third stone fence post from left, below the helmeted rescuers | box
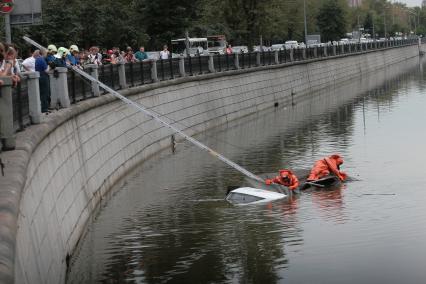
[49,67,71,108]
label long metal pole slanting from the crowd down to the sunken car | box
[23,36,264,183]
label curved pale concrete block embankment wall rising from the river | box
[0,45,419,283]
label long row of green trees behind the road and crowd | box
[5,0,426,53]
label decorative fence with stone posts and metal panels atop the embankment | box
[0,38,420,151]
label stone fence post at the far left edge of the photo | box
[0,77,16,150]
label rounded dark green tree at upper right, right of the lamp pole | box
[317,0,347,41]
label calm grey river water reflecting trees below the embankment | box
[67,56,426,284]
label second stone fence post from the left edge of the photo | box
[26,72,41,124]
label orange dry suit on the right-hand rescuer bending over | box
[307,154,347,181]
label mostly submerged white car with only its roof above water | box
[226,187,287,205]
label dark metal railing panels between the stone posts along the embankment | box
[62,39,416,103]
